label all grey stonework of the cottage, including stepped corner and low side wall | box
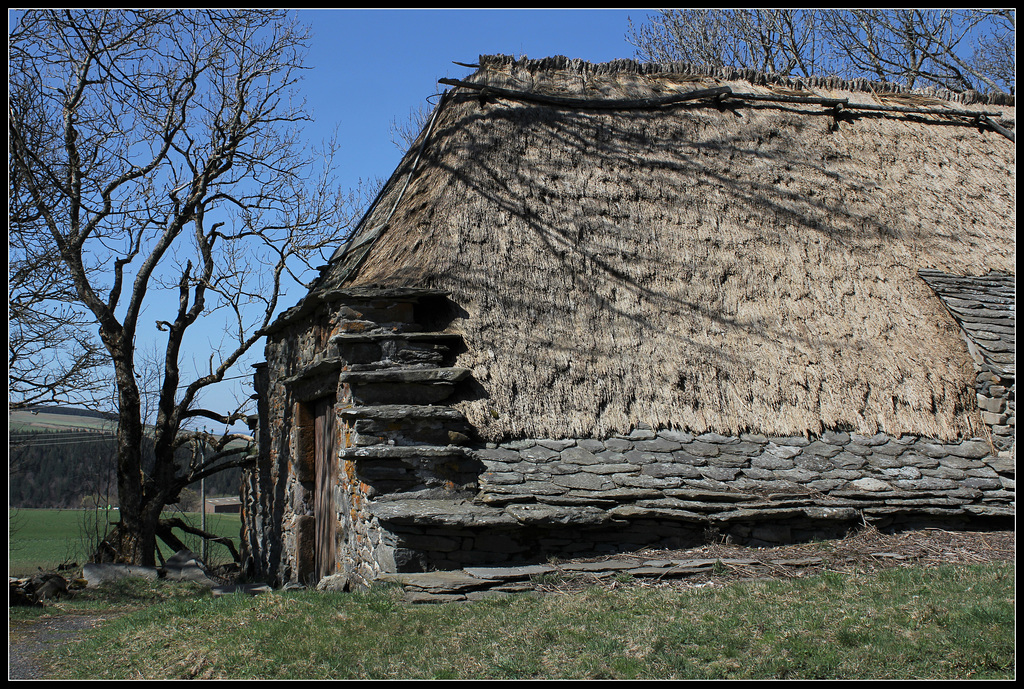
[244,283,1015,589]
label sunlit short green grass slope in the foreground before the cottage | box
[37,563,1015,680]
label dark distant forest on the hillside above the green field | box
[8,430,241,511]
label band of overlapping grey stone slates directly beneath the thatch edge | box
[477,429,1014,515]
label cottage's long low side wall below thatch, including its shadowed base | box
[357,429,1014,571]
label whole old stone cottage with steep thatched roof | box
[243,56,1015,586]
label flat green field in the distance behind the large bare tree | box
[7,510,241,576]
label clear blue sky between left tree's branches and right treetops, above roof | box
[298,9,649,196]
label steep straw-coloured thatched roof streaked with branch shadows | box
[318,56,1016,439]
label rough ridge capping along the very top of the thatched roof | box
[478,54,1015,106]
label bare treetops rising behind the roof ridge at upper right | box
[627,9,1016,93]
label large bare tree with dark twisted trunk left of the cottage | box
[8,9,356,565]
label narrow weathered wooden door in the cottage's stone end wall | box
[313,399,338,580]
